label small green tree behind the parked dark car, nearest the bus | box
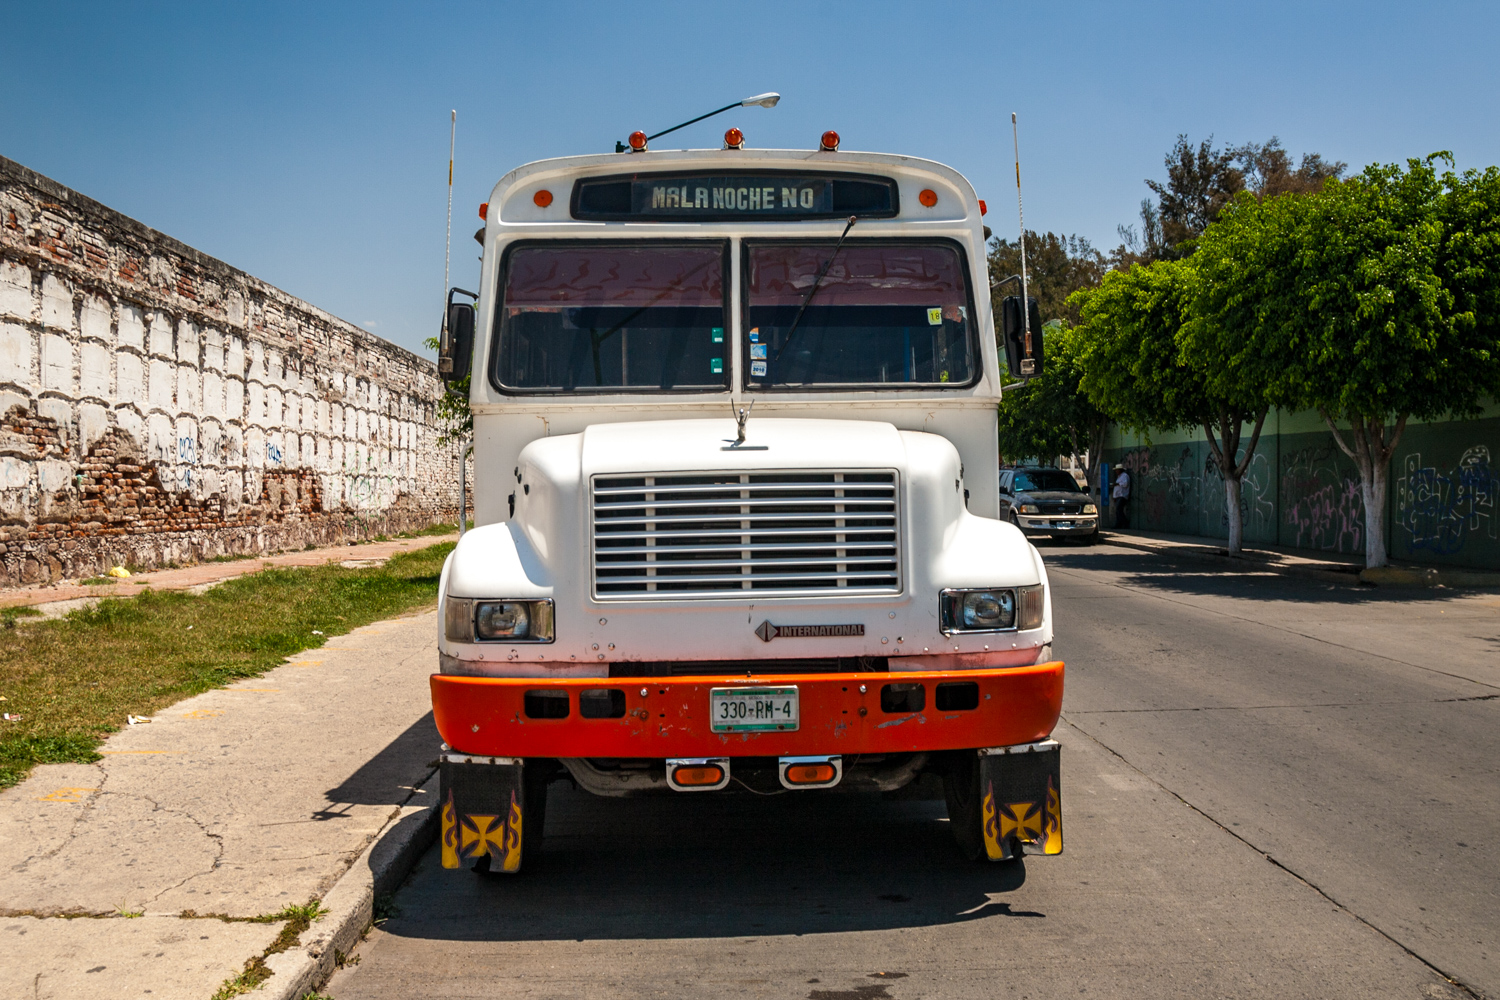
[999,319,1109,489]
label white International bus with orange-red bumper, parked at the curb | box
[432,133,1064,871]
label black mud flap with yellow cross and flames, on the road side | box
[980,739,1062,861]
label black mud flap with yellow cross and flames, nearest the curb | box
[438,753,527,873]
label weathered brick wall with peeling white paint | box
[0,157,458,586]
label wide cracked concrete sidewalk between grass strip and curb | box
[0,611,440,1000]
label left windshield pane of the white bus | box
[494,243,729,393]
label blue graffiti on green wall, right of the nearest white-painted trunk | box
[1397,445,1500,555]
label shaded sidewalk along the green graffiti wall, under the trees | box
[1100,529,1500,588]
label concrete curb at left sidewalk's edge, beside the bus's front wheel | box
[255,771,438,1000]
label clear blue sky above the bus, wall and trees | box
[0,0,1500,349]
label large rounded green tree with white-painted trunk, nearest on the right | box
[1263,153,1500,567]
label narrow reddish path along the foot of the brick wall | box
[0,531,459,610]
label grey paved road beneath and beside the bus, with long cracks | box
[324,547,1500,1000]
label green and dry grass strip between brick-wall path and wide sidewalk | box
[0,543,453,789]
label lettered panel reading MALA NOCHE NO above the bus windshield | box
[630,177,833,217]
